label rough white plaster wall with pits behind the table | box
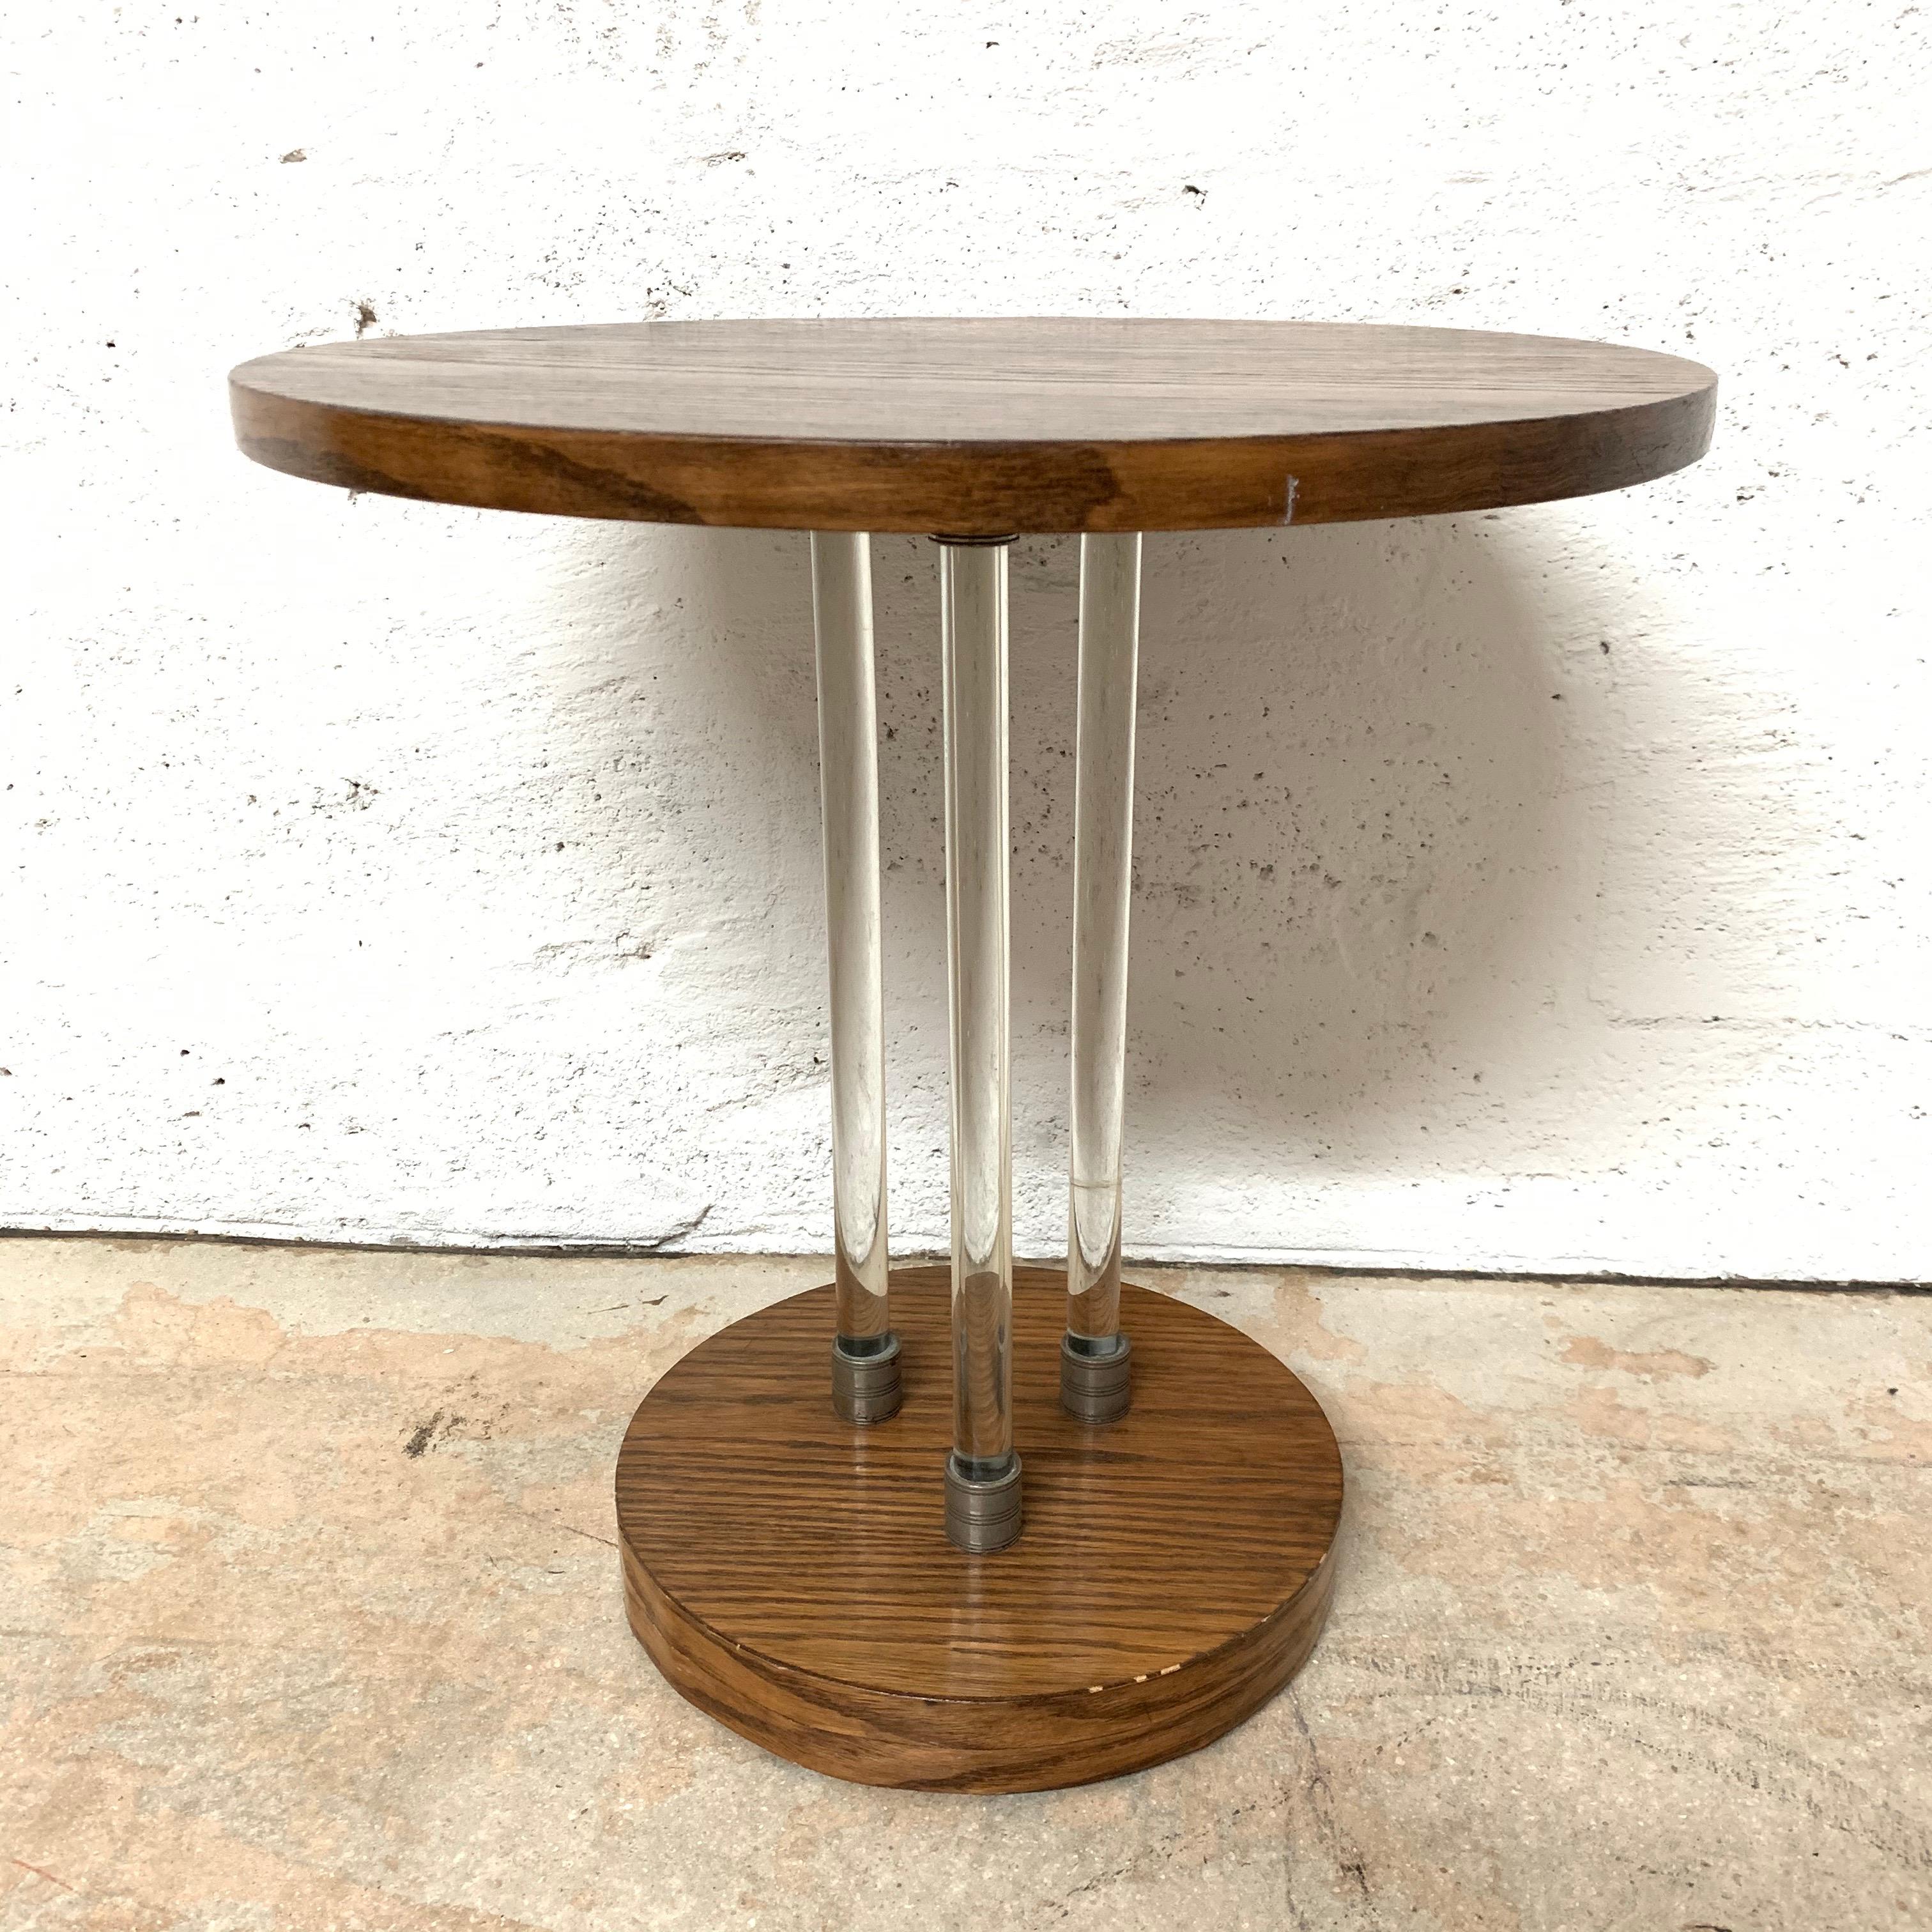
[0,0,1932,1279]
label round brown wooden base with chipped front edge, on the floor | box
[617,1268,1341,1791]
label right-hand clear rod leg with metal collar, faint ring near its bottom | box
[1061,535,1140,1422]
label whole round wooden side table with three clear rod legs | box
[230,319,1715,1791]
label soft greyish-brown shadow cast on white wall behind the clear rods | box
[583,518,1598,1250]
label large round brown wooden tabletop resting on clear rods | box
[230,319,1715,535]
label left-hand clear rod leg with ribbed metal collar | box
[811,532,898,1422]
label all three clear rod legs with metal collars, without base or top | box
[811,533,1140,1551]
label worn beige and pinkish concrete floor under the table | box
[0,1238,1932,1932]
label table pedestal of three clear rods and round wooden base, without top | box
[617,532,1341,1791]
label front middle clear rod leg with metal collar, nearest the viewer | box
[939,537,1020,1551]
